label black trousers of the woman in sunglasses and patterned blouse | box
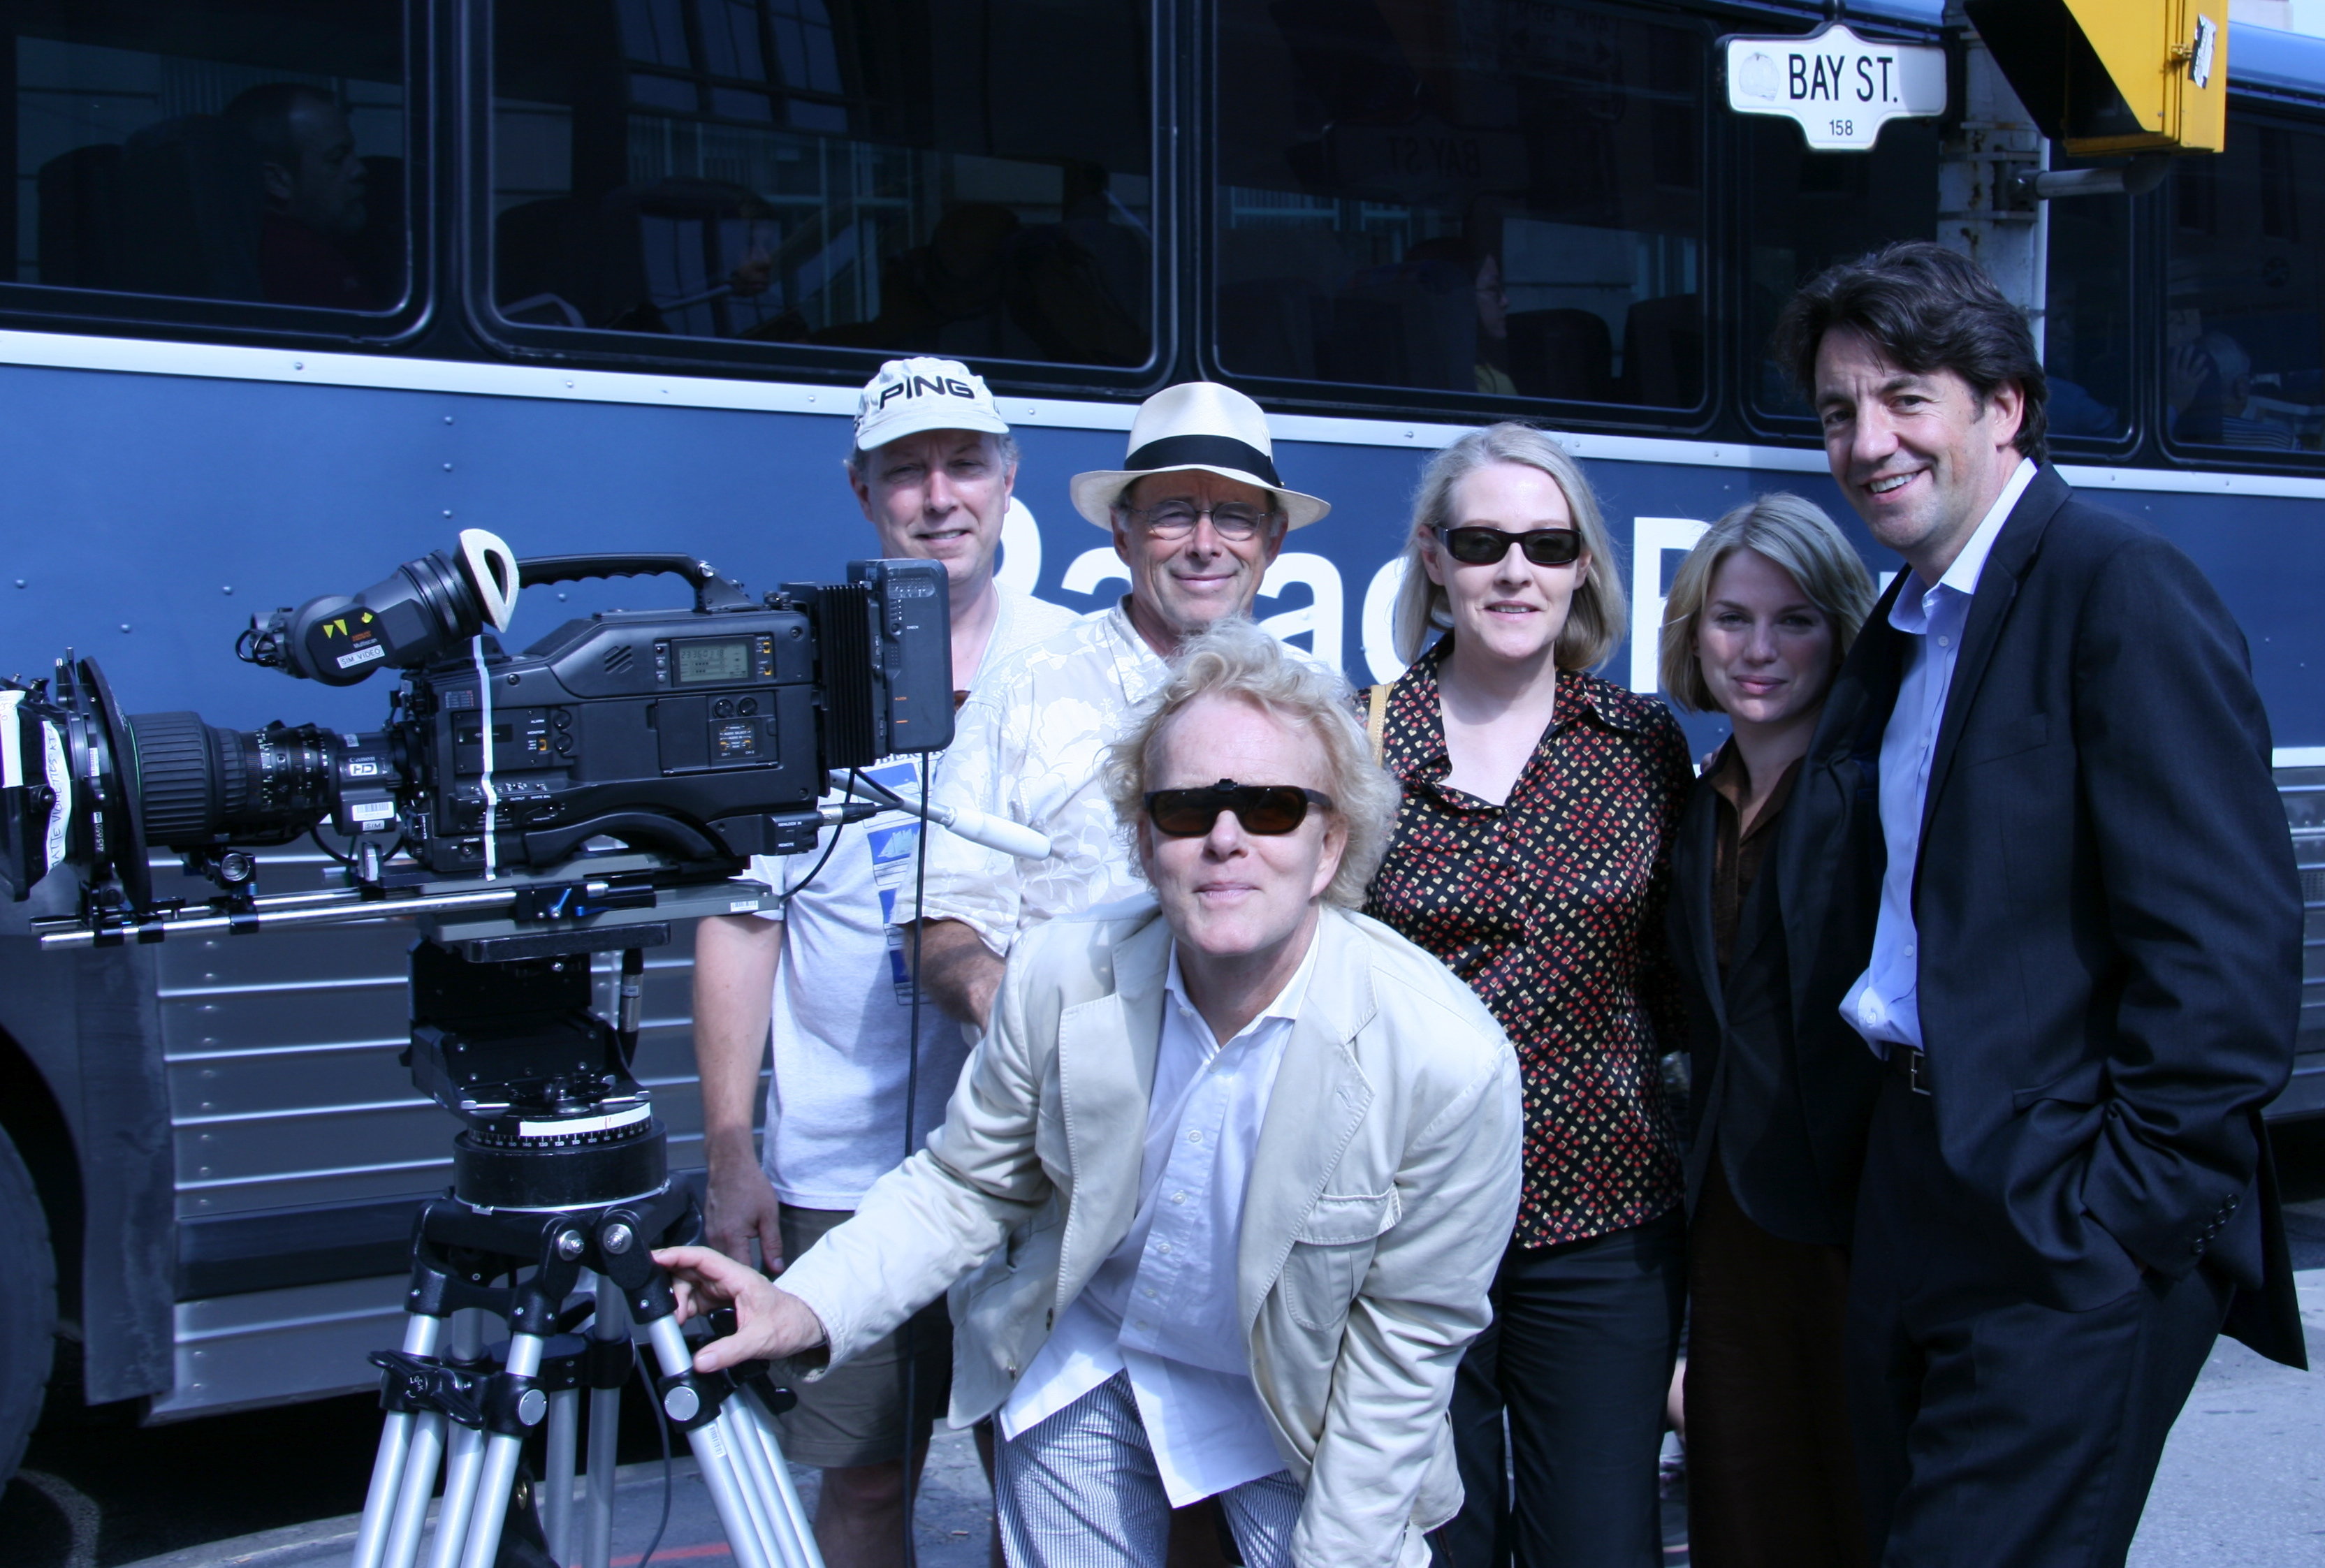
[1432,1208,1688,1568]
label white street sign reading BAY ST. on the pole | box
[1721,23,1946,154]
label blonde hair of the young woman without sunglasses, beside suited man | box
[1660,490,1876,713]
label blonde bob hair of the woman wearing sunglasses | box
[1390,423,1630,669]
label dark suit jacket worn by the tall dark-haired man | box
[1812,469,2304,1366]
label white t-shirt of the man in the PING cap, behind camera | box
[751,587,1074,1210]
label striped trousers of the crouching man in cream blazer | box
[993,1373,1306,1568]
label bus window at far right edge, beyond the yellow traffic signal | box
[2164,109,2325,455]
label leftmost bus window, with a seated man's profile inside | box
[0,0,407,312]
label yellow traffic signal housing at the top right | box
[1962,0,2227,156]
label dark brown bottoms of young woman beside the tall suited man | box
[1686,1150,1865,1568]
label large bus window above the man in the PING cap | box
[493,0,1153,367]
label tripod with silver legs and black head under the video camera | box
[339,925,823,1568]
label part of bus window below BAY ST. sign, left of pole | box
[1735,116,1937,420]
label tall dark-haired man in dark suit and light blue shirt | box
[1779,244,2304,1568]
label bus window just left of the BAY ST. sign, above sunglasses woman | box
[1216,0,1709,409]
